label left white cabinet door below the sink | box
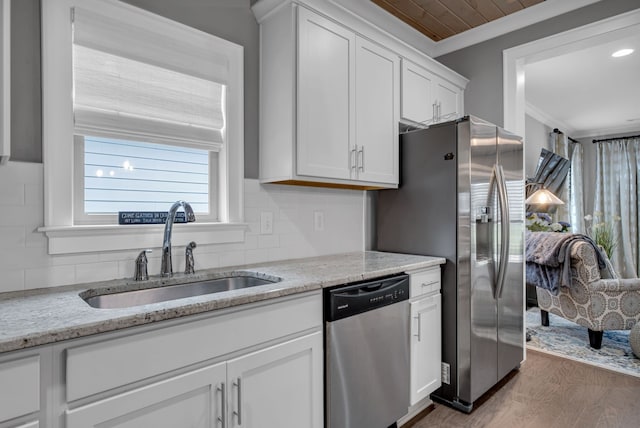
[66,363,228,428]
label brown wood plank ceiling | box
[371,0,544,42]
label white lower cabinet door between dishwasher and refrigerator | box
[410,294,442,405]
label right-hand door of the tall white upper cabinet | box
[356,37,400,184]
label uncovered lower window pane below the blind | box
[75,137,216,217]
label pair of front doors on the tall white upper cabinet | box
[296,7,400,187]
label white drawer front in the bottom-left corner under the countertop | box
[0,355,40,422]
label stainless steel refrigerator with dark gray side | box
[376,116,524,412]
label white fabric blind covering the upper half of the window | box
[73,7,228,151]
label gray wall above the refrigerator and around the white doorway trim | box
[436,0,640,126]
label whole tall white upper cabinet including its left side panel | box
[254,3,400,189]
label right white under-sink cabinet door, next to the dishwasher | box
[227,332,323,428]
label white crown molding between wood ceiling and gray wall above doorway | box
[433,0,601,57]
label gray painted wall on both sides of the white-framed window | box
[11,0,259,178]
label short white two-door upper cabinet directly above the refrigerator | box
[401,58,464,126]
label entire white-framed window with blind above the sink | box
[42,0,244,253]
